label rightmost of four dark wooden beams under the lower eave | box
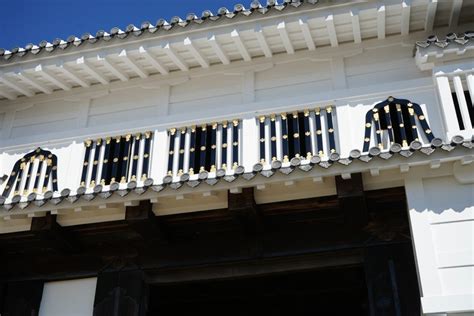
[336,173,368,233]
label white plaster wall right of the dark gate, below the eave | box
[405,174,474,314]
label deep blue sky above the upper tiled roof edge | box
[0,0,241,49]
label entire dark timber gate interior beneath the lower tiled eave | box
[0,174,420,315]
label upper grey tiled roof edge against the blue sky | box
[0,0,319,61]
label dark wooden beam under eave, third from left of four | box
[228,188,264,257]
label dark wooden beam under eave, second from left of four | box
[125,200,170,242]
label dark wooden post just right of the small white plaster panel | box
[94,270,148,316]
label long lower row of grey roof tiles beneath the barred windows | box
[0,136,474,211]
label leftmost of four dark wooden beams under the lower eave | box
[30,213,80,253]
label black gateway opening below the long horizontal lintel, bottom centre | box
[148,266,368,316]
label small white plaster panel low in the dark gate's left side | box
[39,278,97,316]
